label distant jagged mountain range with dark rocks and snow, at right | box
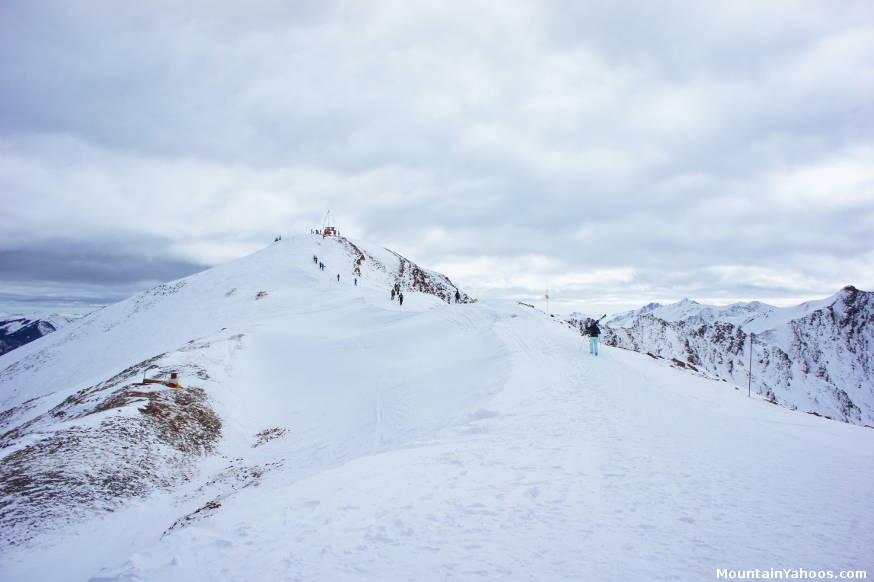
[603,287,874,426]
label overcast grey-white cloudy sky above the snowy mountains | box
[0,0,874,318]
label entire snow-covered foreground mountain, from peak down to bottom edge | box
[0,236,874,582]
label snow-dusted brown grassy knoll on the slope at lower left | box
[0,356,222,544]
